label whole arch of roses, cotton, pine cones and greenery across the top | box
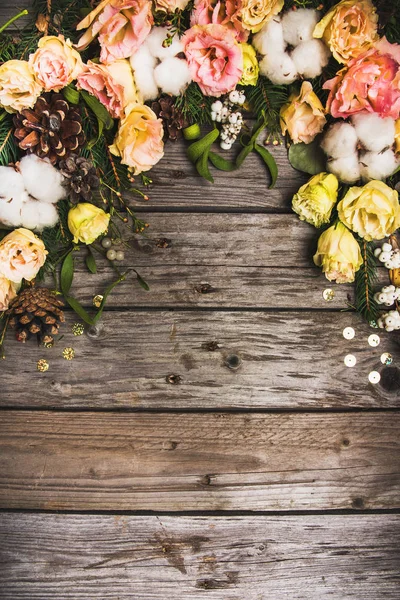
[0,0,400,360]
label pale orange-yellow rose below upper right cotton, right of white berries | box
[280,81,326,144]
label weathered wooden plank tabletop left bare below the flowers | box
[0,1,400,600]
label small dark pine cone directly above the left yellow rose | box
[58,154,99,204]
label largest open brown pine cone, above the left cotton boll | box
[14,92,85,165]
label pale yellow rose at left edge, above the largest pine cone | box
[0,60,42,112]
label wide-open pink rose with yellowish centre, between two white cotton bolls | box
[182,24,243,96]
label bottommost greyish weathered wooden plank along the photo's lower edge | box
[0,514,400,600]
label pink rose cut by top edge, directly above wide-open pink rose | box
[190,0,249,42]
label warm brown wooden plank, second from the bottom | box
[0,412,400,511]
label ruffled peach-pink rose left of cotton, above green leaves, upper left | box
[77,59,138,119]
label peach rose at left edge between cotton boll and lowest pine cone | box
[0,228,47,283]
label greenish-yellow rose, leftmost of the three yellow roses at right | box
[292,173,339,227]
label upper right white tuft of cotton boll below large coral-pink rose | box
[351,113,395,152]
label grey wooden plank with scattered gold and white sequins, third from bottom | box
[1,311,400,409]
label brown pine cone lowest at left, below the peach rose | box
[6,287,65,344]
